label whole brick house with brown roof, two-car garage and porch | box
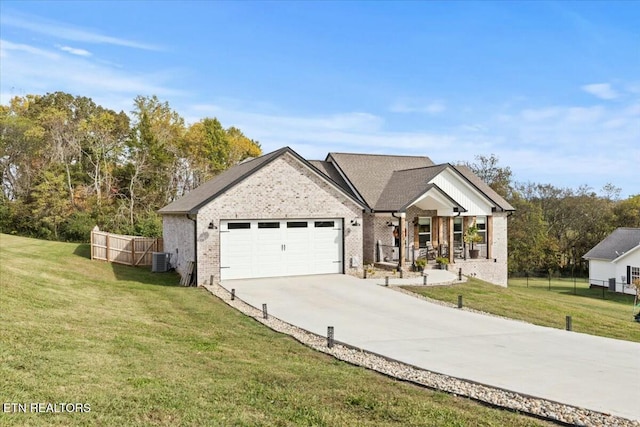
[159,147,514,286]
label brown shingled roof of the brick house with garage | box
[159,147,514,214]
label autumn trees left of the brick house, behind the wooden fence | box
[0,92,261,241]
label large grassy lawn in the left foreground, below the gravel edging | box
[0,235,548,426]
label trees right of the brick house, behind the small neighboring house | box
[466,154,640,275]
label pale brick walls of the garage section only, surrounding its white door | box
[163,153,363,285]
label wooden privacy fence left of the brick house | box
[91,226,162,266]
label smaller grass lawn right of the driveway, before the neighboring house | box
[405,278,640,342]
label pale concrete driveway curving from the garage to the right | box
[222,275,640,420]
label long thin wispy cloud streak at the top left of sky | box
[0,13,160,50]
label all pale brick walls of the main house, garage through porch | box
[163,151,507,286]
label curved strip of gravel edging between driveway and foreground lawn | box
[204,285,640,427]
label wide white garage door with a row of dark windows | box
[220,218,343,280]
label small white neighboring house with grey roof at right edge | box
[583,227,640,294]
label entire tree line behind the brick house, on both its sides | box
[0,92,640,274]
